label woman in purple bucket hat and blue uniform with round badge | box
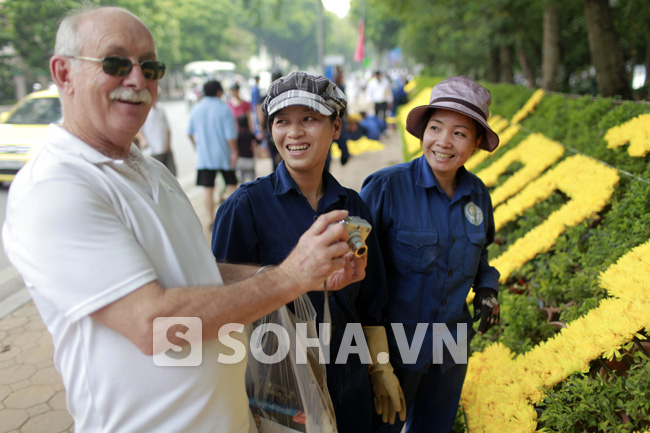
[361,77,499,433]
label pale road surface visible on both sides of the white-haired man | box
[0,100,196,318]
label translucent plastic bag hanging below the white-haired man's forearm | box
[246,295,337,433]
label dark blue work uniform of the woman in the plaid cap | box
[212,162,388,433]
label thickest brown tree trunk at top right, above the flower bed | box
[582,0,632,99]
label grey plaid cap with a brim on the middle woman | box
[262,71,348,117]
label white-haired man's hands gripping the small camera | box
[279,210,352,293]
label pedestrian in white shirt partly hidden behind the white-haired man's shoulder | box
[139,91,176,176]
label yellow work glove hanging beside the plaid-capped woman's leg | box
[363,326,406,425]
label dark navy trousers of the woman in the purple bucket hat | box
[376,364,467,433]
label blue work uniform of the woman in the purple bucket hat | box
[361,156,499,433]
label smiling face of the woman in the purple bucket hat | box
[422,108,482,176]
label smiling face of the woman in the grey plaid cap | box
[271,105,341,175]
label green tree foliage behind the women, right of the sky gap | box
[353,0,650,98]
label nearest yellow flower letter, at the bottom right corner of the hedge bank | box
[461,238,650,433]
